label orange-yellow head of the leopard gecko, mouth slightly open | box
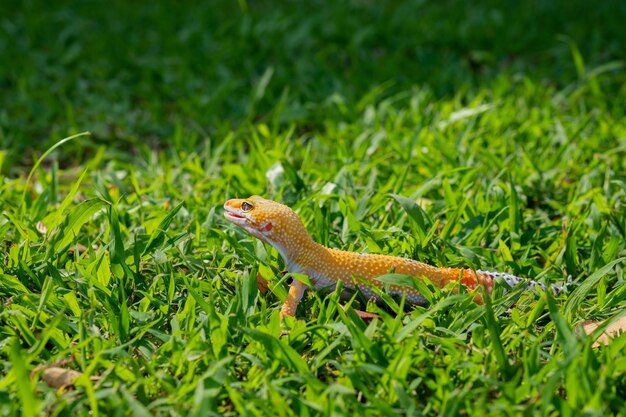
[224,195,310,250]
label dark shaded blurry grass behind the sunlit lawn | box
[0,0,626,160]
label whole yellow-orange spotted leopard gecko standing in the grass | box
[224,196,545,316]
